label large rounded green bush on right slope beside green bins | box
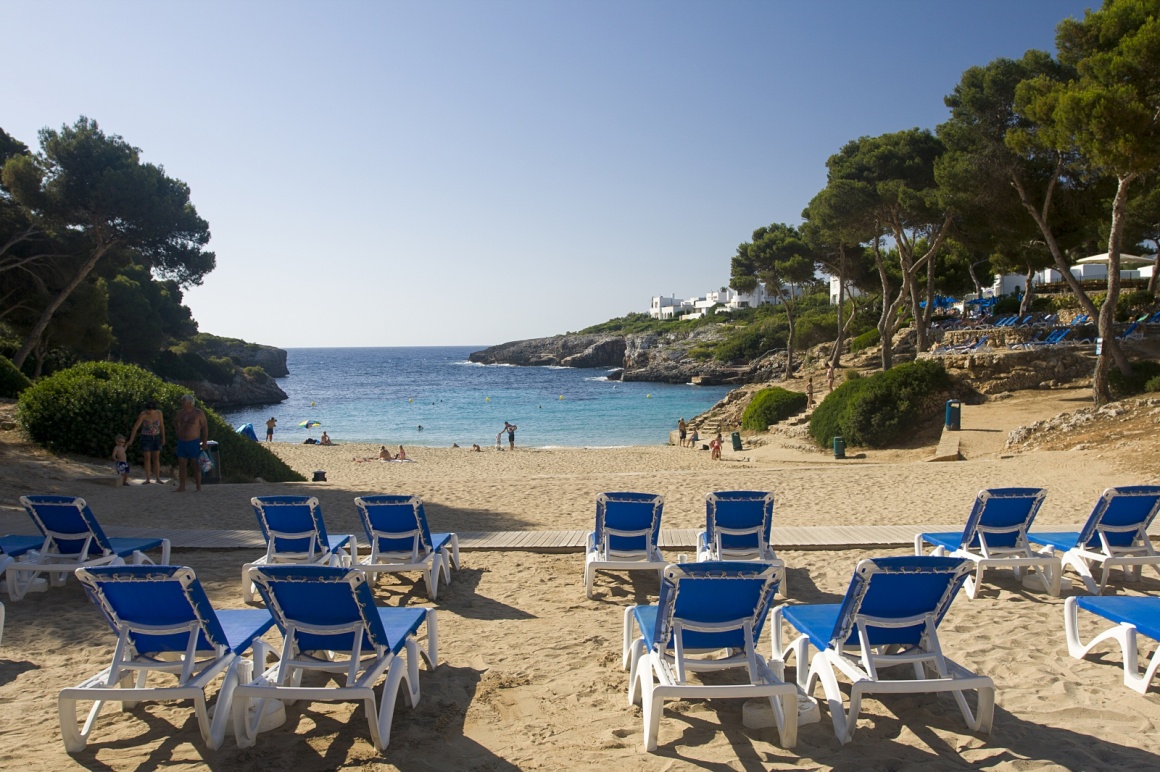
[810,359,950,447]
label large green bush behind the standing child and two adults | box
[17,362,303,482]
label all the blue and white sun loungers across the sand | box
[0,486,1160,752]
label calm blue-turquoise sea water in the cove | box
[223,345,728,447]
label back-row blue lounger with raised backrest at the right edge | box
[1028,486,1160,595]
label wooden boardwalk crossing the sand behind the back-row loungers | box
[0,515,1160,553]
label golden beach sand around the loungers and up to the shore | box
[0,392,1160,771]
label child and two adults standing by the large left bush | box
[113,394,210,493]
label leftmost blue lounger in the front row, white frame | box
[57,566,274,753]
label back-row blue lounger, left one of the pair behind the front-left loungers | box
[241,496,358,603]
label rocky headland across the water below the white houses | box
[467,327,752,384]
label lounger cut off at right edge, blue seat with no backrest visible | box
[1064,596,1160,694]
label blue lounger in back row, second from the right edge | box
[914,488,1061,599]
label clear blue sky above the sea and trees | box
[0,0,1099,347]
